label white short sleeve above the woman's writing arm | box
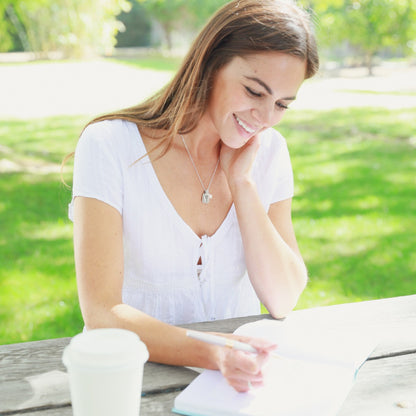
[68,121,123,221]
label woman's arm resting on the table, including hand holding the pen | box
[74,197,275,391]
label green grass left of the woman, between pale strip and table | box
[0,173,82,344]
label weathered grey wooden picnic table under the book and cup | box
[0,295,416,416]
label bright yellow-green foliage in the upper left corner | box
[0,0,131,56]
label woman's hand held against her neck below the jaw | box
[220,135,260,185]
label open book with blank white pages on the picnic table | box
[172,319,376,416]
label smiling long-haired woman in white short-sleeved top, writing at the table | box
[70,0,318,391]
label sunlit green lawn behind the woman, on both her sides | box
[0,109,416,344]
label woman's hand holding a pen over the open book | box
[211,334,277,392]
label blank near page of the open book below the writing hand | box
[175,359,353,416]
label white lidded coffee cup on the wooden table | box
[62,328,149,416]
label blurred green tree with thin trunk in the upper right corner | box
[304,0,416,74]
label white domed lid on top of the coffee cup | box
[64,328,149,367]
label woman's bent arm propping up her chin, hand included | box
[221,137,307,318]
